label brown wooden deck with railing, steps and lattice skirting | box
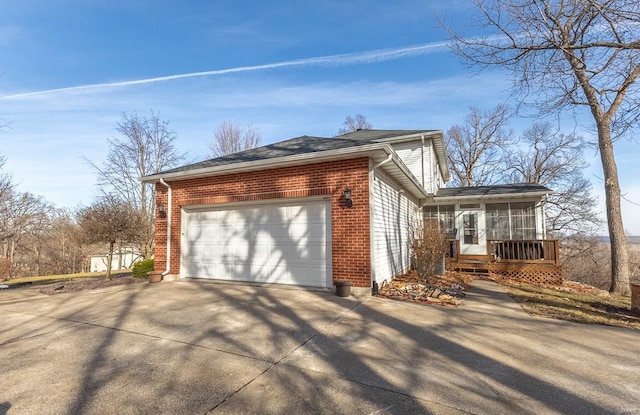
[446,239,562,284]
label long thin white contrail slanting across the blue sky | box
[0,42,447,100]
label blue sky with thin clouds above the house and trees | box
[0,0,640,234]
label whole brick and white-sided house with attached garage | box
[142,130,551,293]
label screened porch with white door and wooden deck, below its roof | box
[424,201,562,283]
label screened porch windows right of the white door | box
[485,202,536,239]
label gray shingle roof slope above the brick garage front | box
[158,135,371,174]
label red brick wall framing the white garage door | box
[155,158,371,287]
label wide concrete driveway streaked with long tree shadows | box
[0,281,640,414]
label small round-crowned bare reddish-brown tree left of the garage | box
[78,194,146,278]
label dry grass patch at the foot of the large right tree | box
[502,281,640,330]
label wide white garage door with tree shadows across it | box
[180,200,332,288]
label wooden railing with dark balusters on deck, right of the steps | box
[487,239,560,265]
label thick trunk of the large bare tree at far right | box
[598,121,631,295]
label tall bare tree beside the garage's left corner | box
[85,111,184,257]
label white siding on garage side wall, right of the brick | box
[373,171,418,284]
